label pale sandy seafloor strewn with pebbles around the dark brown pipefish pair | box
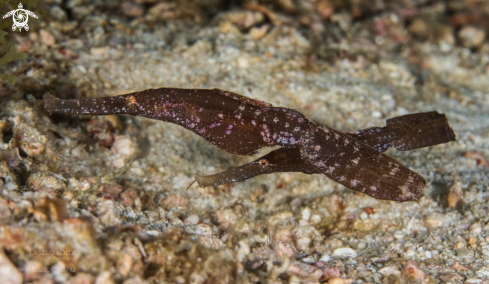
[0,1,489,283]
